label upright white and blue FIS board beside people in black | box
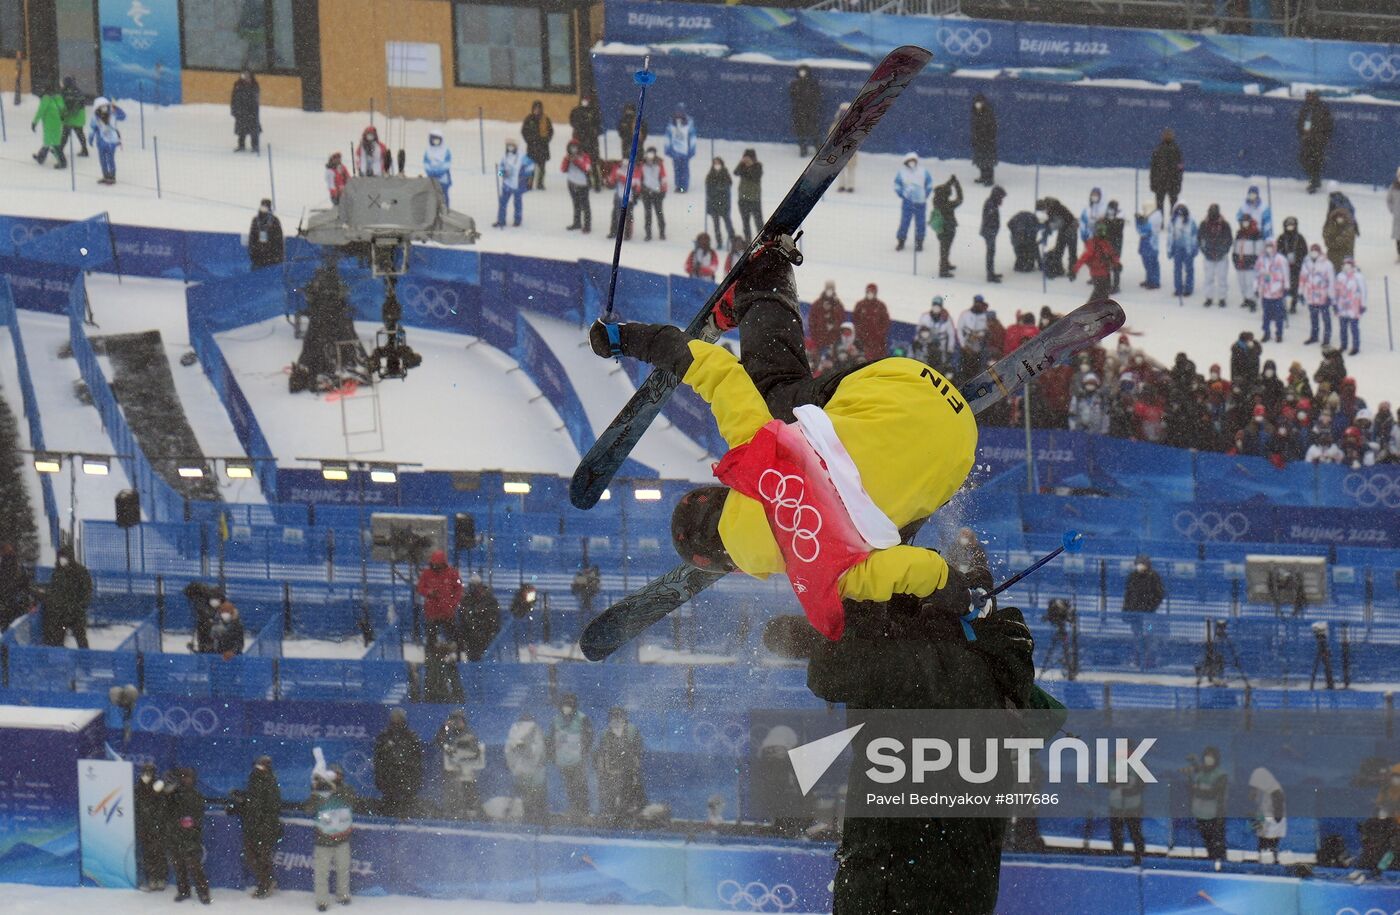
[78,760,136,888]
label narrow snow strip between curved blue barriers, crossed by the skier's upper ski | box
[526,312,714,481]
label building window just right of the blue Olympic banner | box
[180,0,297,73]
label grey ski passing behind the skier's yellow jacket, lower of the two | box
[578,299,1127,660]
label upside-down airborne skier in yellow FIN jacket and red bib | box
[589,237,977,639]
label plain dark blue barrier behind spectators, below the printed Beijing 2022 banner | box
[594,51,1400,187]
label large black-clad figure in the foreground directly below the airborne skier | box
[764,584,1035,915]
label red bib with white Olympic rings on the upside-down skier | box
[714,420,871,641]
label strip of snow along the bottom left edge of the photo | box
[0,883,700,915]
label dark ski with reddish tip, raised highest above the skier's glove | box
[568,45,932,509]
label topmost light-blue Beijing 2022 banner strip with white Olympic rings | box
[603,0,1400,94]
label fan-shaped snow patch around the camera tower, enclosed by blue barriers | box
[218,318,578,474]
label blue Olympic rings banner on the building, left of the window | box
[98,0,181,105]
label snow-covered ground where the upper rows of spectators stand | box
[0,98,1400,408]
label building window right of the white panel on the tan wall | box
[452,1,575,92]
